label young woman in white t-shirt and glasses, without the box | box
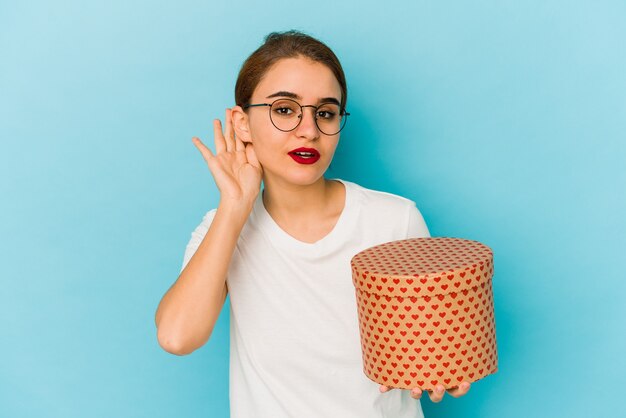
[156,31,470,418]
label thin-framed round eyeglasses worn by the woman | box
[243,99,350,135]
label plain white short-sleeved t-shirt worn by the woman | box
[181,179,429,418]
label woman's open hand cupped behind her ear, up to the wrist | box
[192,109,263,205]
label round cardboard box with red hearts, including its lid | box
[350,237,498,390]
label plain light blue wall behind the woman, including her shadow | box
[0,0,626,418]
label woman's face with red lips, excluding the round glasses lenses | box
[238,57,341,189]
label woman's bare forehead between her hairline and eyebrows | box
[253,57,341,103]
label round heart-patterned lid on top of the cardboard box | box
[350,237,493,298]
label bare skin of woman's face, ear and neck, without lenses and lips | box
[232,58,345,235]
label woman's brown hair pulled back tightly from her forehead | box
[235,30,348,108]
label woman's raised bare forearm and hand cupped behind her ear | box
[155,107,263,355]
